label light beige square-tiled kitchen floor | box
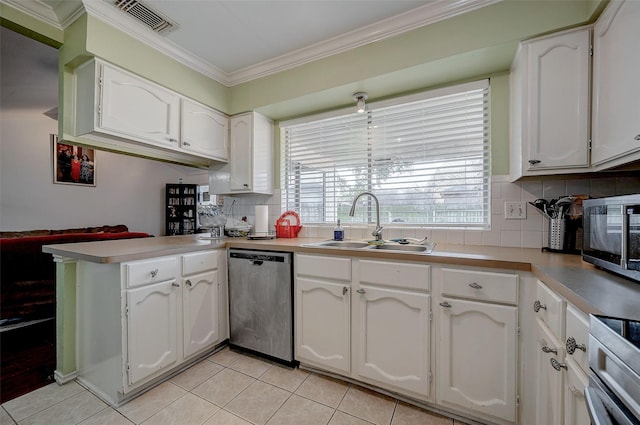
[0,348,470,425]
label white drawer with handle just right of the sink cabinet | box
[442,269,518,304]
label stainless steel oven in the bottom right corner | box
[585,315,640,425]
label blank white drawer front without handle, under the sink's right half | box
[358,260,429,291]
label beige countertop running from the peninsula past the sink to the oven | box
[43,235,640,320]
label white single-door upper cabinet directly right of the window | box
[511,27,591,179]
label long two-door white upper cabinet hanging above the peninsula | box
[73,59,229,166]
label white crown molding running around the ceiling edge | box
[5,0,503,87]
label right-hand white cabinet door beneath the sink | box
[353,285,430,398]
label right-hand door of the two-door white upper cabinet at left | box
[181,99,229,161]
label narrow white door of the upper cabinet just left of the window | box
[230,114,254,191]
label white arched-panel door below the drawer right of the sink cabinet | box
[436,298,516,424]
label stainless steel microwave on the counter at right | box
[582,193,640,283]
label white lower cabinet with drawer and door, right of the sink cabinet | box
[434,268,518,423]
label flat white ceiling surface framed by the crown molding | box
[145,0,428,73]
